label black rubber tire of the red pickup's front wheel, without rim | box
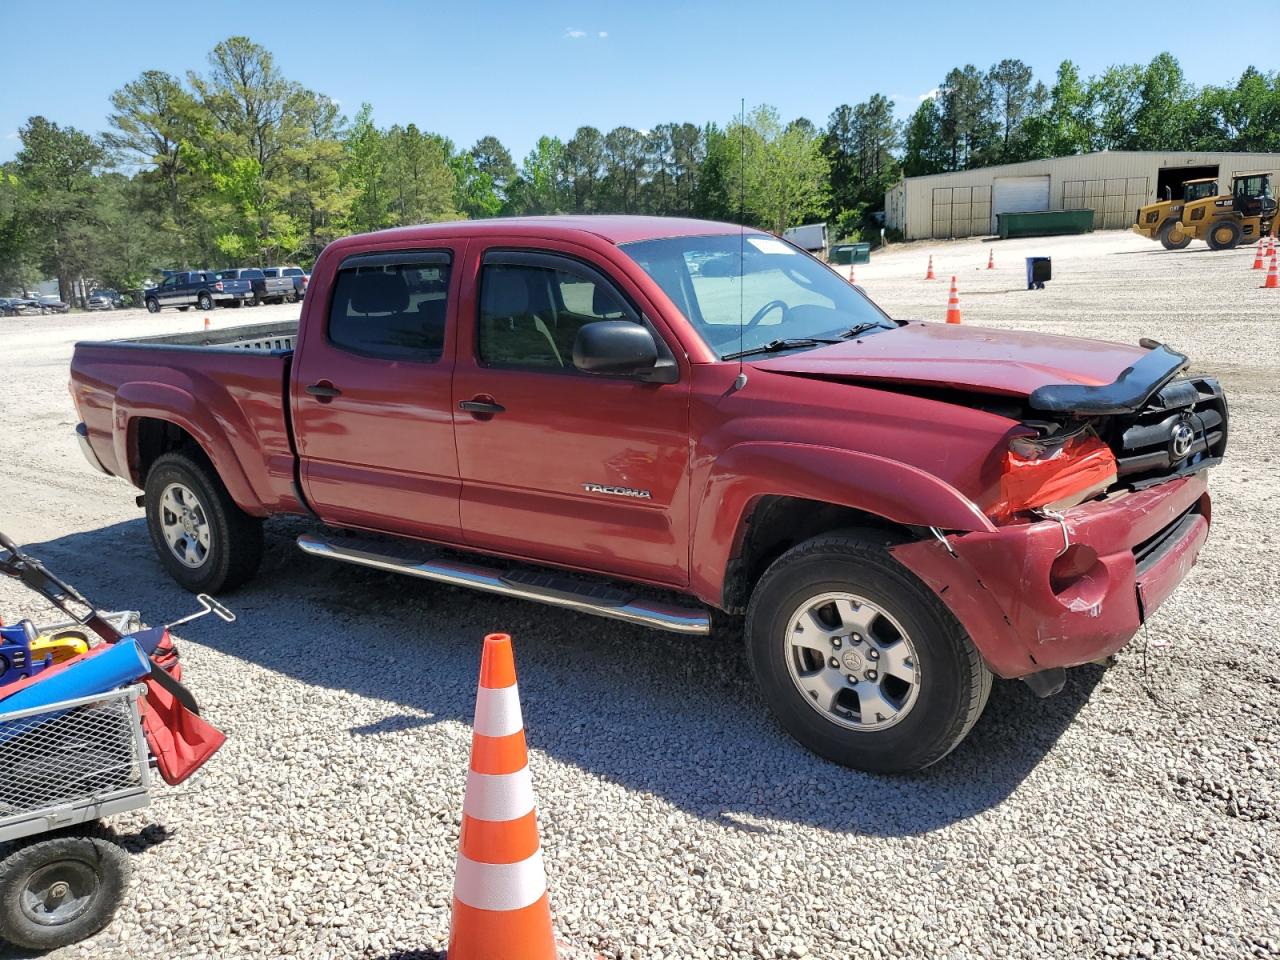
[746,531,992,773]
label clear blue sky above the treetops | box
[0,0,1244,161]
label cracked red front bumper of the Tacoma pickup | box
[893,470,1210,678]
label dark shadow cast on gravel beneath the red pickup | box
[6,520,1102,836]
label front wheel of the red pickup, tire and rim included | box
[746,531,992,773]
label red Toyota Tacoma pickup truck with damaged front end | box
[72,216,1228,771]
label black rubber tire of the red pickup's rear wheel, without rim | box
[145,451,262,594]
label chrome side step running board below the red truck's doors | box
[298,534,710,635]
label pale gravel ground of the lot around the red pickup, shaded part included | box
[0,233,1280,960]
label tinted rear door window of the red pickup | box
[329,251,451,362]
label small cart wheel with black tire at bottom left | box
[0,836,131,950]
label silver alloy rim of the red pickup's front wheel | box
[786,591,920,732]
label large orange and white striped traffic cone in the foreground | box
[449,634,556,960]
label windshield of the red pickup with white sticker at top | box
[621,233,893,358]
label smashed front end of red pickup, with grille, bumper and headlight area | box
[893,342,1228,695]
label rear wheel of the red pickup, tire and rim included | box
[143,452,262,594]
